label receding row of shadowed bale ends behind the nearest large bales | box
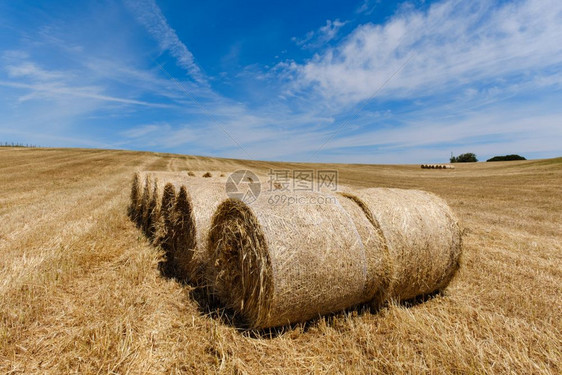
[129,172,226,285]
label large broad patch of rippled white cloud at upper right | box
[289,0,562,104]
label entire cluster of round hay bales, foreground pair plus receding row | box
[130,172,461,328]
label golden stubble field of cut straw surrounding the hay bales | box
[0,148,562,374]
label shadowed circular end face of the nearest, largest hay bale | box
[207,199,273,328]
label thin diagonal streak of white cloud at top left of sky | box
[125,0,206,84]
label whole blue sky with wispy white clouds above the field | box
[0,0,562,163]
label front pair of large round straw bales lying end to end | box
[208,189,461,328]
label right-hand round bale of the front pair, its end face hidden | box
[336,188,461,300]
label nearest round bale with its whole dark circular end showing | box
[208,193,376,328]
